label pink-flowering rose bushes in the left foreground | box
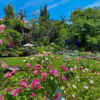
[1,52,68,100]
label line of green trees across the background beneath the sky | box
[0,4,100,50]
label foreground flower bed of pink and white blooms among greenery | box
[0,52,100,100]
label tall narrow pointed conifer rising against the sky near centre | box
[39,5,51,43]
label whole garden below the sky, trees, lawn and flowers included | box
[0,4,100,100]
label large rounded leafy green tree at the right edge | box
[68,8,100,50]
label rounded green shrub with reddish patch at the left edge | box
[0,29,23,56]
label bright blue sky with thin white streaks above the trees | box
[0,0,100,19]
